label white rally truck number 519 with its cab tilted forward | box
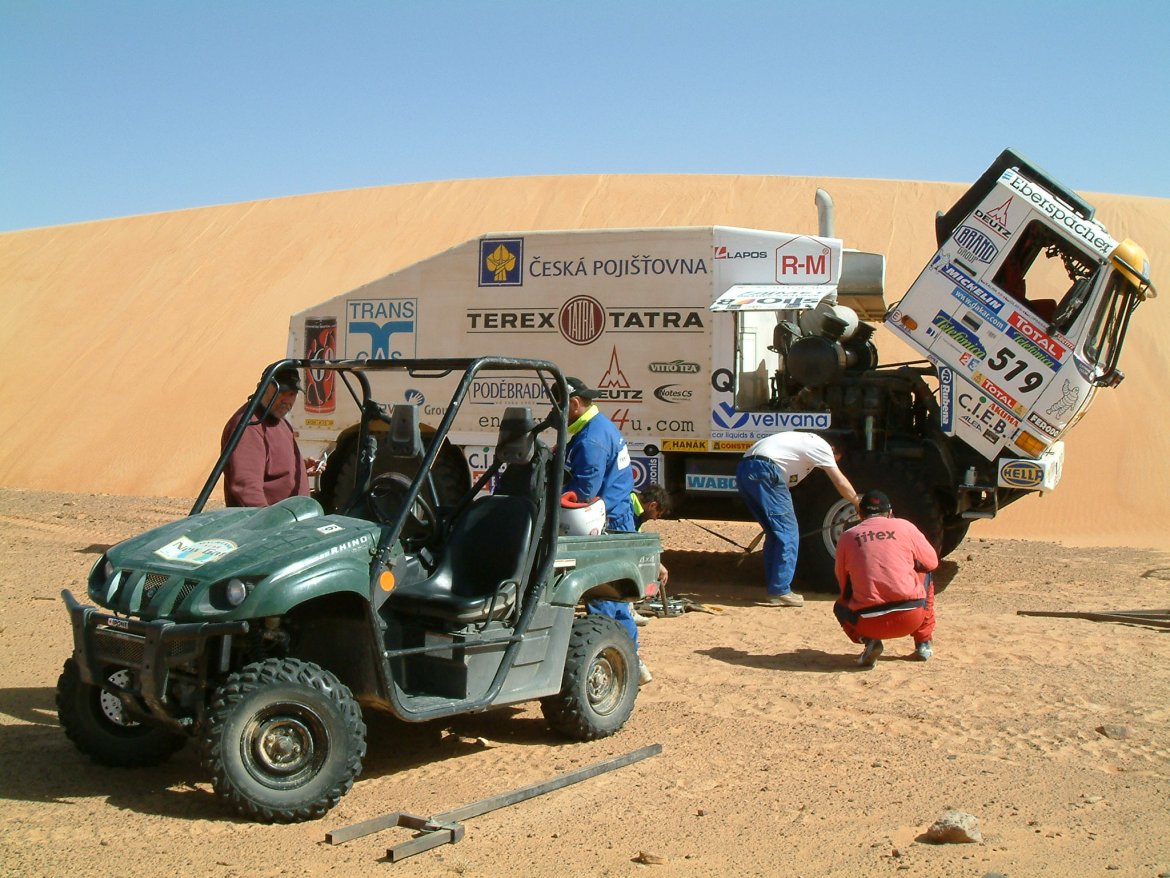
[289,150,1154,588]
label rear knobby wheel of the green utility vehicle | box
[541,616,638,741]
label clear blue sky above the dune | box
[0,0,1170,231]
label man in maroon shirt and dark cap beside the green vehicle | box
[220,368,318,506]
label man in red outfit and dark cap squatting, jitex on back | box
[833,491,938,667]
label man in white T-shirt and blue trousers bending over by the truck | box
[735,431,861,606]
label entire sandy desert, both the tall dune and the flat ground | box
[0,169,1170,878]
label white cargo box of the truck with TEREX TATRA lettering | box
[289,226,885,494]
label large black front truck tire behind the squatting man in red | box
[794,452,943,594]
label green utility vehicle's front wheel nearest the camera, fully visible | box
[204,658,366,823]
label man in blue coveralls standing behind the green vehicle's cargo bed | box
[562,377,654,685]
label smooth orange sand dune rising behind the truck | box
[0,174,1170,548]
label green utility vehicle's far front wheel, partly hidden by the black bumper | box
[57,659,187,768]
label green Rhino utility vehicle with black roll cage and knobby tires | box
[57,357,660,822]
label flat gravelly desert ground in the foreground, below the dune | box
[0,489,1170,878]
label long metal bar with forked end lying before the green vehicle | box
[325,743,662,863]
